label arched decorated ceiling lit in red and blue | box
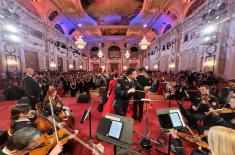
[16,0,205,44]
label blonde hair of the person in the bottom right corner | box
[208,126,235,155]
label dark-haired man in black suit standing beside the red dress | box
[114,68,137,116]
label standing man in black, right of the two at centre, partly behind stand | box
[133,67,151,122]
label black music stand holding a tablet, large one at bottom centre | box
[96,113,134,155]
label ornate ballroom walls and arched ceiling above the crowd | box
[0,0,235,79]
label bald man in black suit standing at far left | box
[22,68,41,109]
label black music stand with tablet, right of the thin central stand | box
[156,108,185,155]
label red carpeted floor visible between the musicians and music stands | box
[0,96,195,155]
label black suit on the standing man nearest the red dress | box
[114,76,134,116]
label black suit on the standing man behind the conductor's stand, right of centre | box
[133,75,151,121]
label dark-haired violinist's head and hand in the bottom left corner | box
[0,127,63,155]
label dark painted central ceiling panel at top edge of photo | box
[81,0,144,25]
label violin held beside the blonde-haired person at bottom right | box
[177,132,210,150]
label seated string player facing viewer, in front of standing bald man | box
[44,86,70,117]
